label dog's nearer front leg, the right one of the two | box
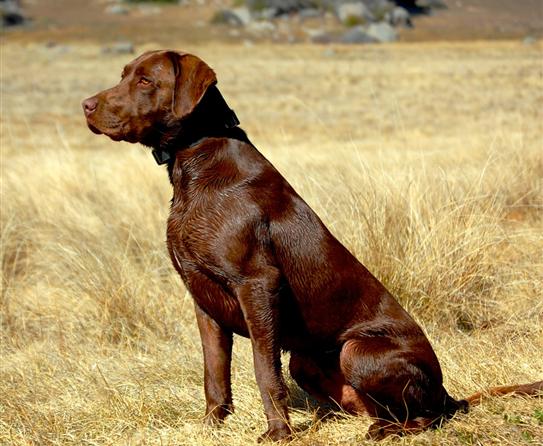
[236,267,291,441]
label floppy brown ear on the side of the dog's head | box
[168,51,217,118]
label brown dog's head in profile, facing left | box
[82,51,217,142]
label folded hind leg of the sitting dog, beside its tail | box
[340,336,461,439]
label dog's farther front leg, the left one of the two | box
[194,303,234,424]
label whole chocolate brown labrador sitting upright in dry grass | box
[83,51,543,440]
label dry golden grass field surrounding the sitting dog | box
[0,42,543,446]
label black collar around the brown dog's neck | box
[153,85,239,165]
